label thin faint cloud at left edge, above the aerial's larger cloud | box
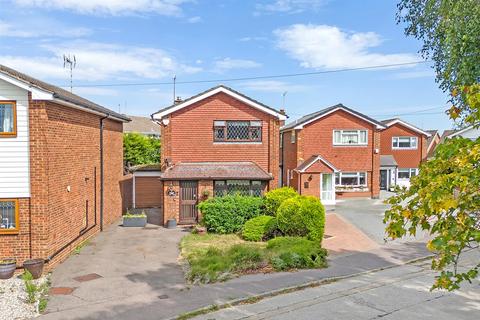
[0,18,92,38]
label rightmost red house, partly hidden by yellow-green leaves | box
[380,119,431,190]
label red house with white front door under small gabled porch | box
[281,104,385,204]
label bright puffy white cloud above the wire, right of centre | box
[274,24,419,69]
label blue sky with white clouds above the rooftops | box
[0,0,452,130]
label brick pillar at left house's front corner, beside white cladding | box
[28,93,50,258]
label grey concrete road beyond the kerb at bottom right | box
[193,250,480,320]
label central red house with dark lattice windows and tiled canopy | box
[152,85,286,224]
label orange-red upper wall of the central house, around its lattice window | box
[161,93,280,182]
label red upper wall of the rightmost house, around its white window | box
[380,123,428,168]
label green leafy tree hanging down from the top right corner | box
[397,0,480,124]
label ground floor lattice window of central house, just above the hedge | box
[213,180,265,197]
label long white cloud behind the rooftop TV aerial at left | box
[0,41,200,82]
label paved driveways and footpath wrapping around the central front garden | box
[41,200,429,319]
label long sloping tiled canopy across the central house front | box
[160,161,273,180]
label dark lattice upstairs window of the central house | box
[213,120,262,142]
